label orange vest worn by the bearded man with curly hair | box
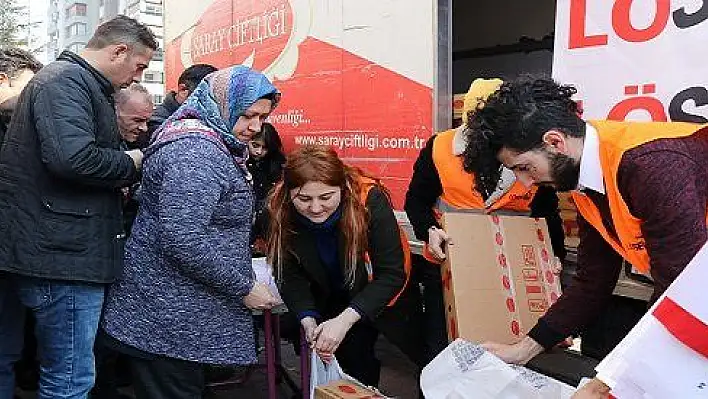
[572,121,708,274]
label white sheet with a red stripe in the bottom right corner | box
[597,245,708,399]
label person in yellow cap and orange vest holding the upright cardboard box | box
[405,79,565,357]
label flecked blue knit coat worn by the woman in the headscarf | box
[103,133,256,364]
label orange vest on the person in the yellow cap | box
[423,129,536,263]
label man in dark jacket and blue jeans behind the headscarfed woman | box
[0,16,158,398]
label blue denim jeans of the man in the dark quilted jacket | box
[0,274,105,399]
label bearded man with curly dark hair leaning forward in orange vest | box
[465,79,708,393]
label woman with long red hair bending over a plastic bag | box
[268,146,423,386]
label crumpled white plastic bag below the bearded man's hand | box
[420,339,575,399]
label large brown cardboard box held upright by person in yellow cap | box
[442,212,560,343]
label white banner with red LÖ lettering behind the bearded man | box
[553,0,708,123]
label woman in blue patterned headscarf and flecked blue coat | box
[102,66,280,399]
